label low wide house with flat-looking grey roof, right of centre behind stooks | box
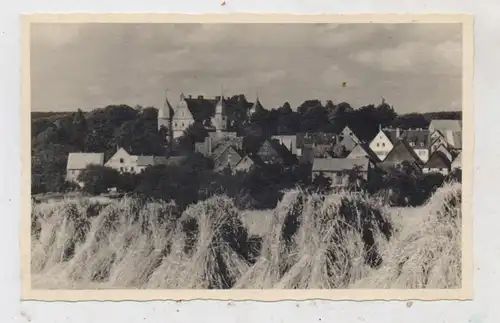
[312,157,372,187]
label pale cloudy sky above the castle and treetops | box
[31,23,462,113]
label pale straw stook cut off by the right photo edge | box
[354,183,462,288]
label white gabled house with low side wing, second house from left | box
[104,148,167,174]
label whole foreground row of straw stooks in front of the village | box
[31,184,461,289]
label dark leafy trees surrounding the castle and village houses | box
[31,96,461,207]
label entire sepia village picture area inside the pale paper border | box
[26,15,472,298]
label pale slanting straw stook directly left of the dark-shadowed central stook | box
[63,198,177,287]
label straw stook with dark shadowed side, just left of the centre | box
[148,196,250,289]
